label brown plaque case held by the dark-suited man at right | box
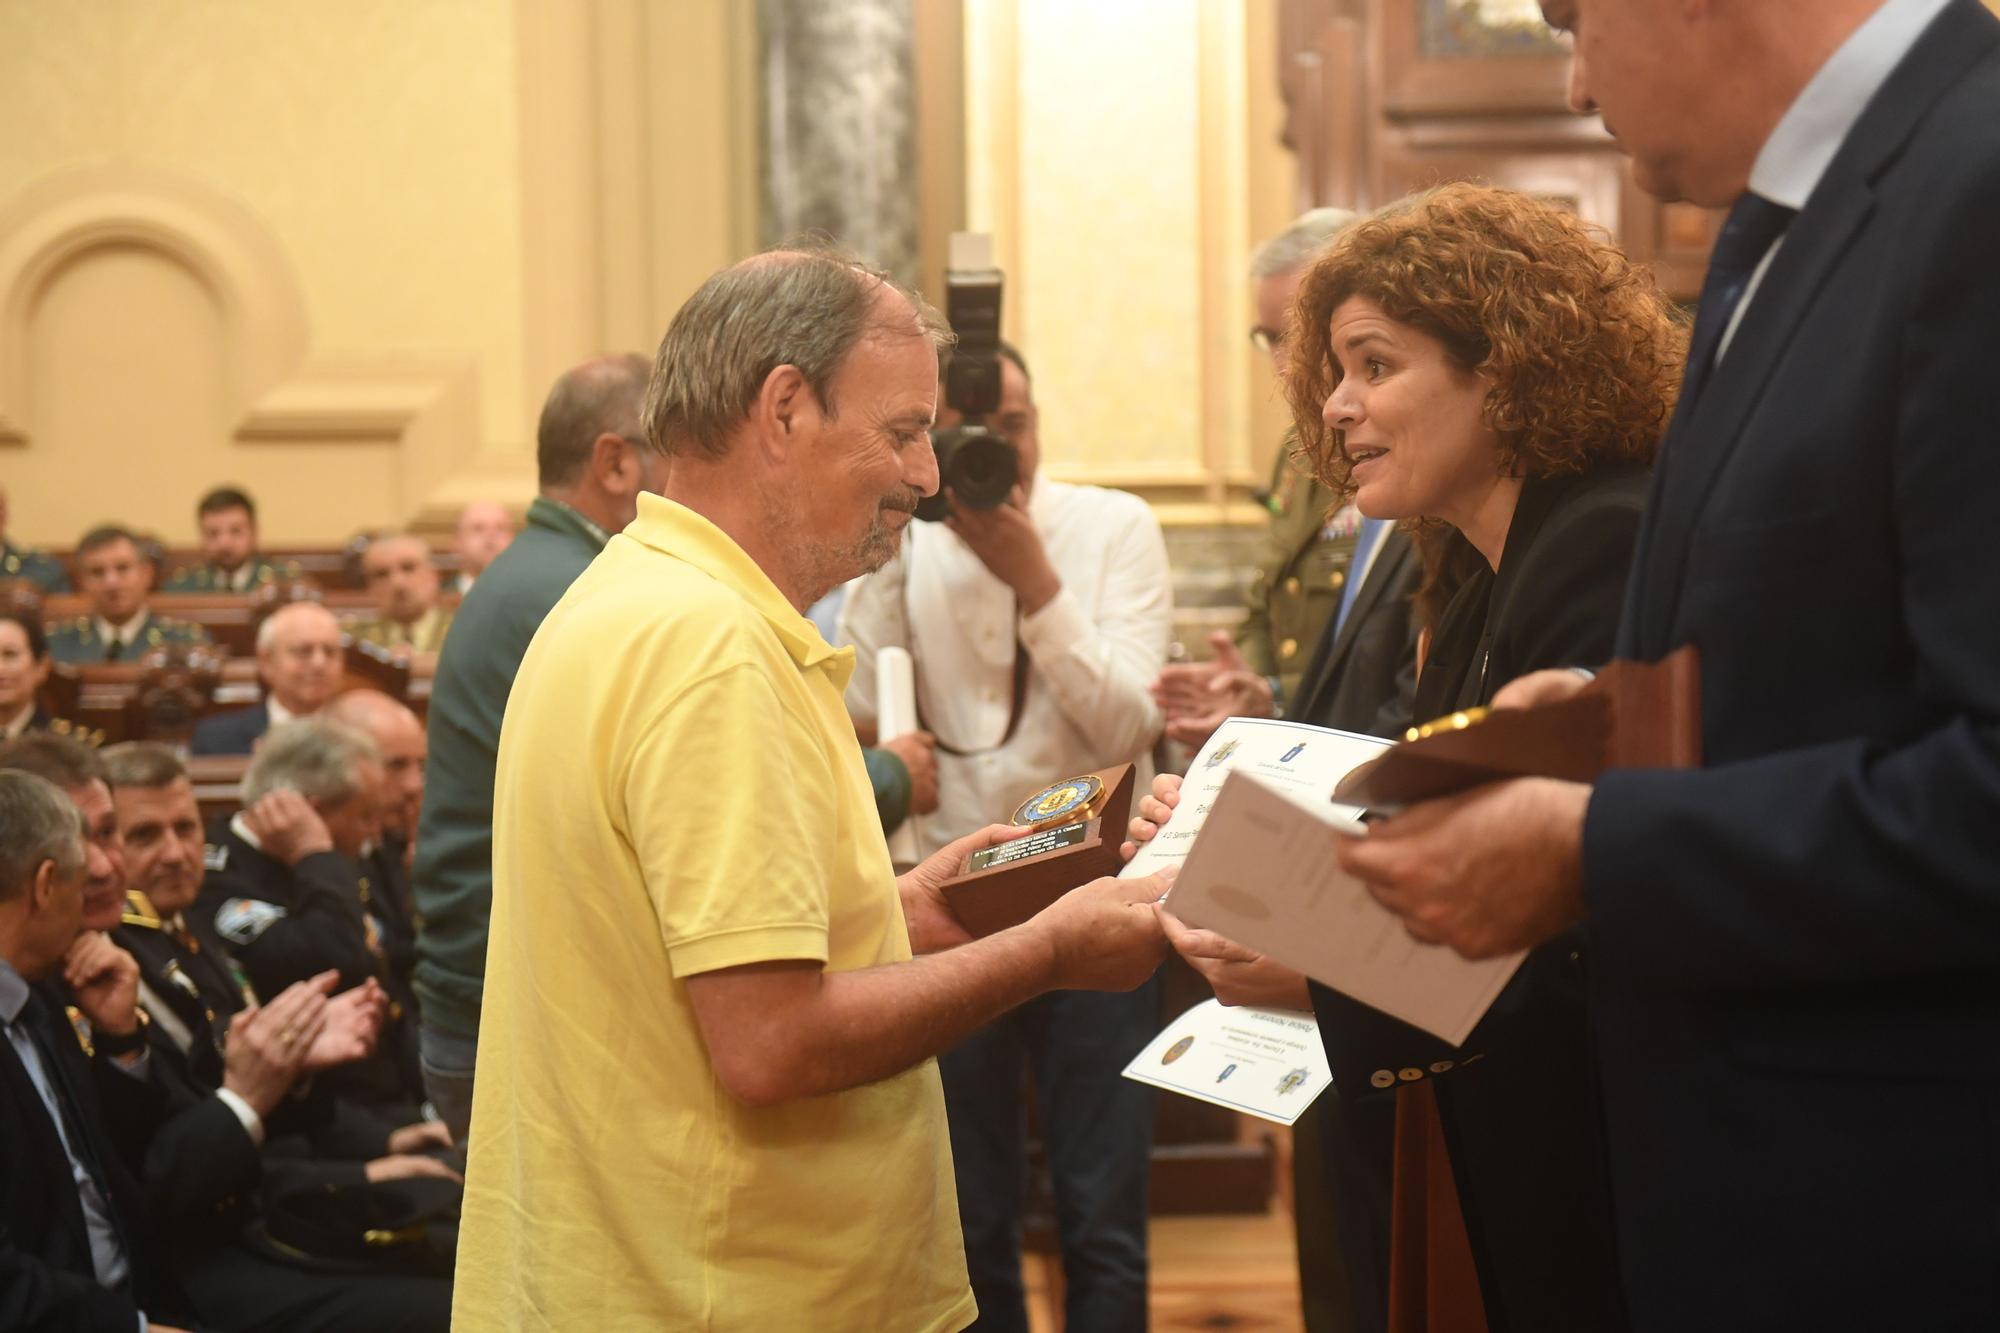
[1334,644,1702,807]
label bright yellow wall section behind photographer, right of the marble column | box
[964,0,1290,520]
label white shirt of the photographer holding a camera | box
[838,476,1174,857]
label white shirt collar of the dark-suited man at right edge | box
[1716,0,1952,364]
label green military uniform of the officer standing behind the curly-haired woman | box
[1236,440,1360,713]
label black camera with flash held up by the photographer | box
[916,232,1020,522]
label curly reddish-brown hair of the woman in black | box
[1286,184,1688,622]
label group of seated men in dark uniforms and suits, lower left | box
[0,712,462,1333]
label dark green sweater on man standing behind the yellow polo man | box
[412,496,610,1037]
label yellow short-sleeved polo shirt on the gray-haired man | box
[454,494,974,1333]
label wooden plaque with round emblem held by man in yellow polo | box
[944,765,1132,937]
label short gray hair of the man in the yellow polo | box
[646,242,952,458]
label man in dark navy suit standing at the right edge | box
[1342,0,2000,1333]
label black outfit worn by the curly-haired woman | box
[1312,466,1646,1333]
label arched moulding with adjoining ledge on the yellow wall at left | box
[0,162,480,544]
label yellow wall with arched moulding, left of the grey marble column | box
[0,0,754,544]
